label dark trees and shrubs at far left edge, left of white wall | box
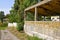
[0,11,8,30]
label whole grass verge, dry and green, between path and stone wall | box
[8,27,43,40]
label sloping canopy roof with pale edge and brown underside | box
[24,0,60,16]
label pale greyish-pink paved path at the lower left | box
[1,30,19,40]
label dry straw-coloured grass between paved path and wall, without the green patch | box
[8,27,27,40]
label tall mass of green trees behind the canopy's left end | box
[8,0,37,31]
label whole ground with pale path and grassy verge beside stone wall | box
[0,27,42,40]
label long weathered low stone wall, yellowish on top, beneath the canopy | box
[24,21,60,40]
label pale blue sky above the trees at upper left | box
[0,0,14,15]
